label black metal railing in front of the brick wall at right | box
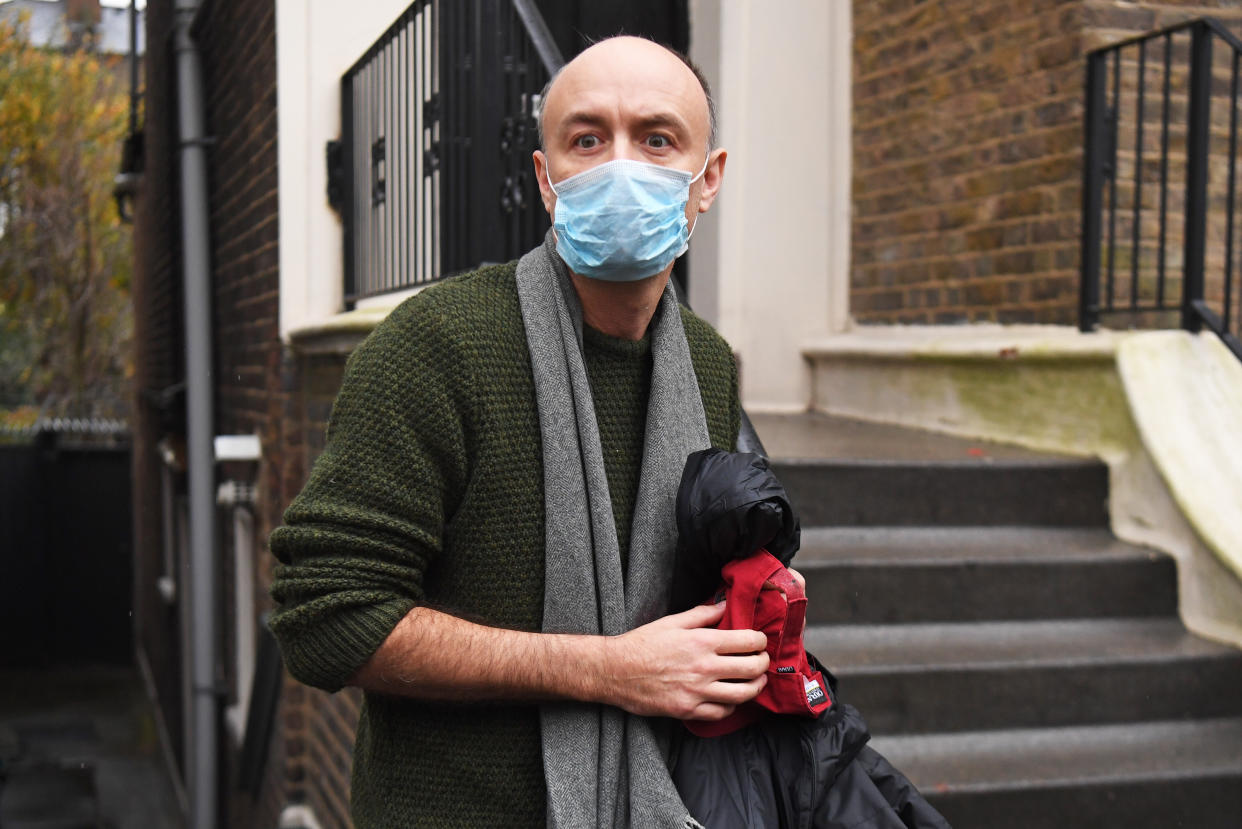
[1079,17,1242,359]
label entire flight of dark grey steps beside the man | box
[754,415,1242,829]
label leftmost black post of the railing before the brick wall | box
[1078,52,1108,332]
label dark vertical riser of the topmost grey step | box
[773,457,1108,527]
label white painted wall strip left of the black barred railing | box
[276,0,410,339]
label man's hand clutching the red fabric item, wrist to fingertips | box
[600,603,769,720]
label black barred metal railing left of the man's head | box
[328,0,563,306]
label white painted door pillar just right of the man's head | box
[689,0,852,411]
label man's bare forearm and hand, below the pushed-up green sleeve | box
[349,596,769,720]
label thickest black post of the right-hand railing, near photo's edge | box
[1181,22,1212,332]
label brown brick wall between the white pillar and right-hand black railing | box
[851,0,1242,324]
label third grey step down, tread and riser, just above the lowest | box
[805,618,1242,735]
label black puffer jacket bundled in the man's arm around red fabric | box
[672,449,949,829]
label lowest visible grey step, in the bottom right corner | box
[872,717,1242,829]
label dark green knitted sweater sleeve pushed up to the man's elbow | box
[270,302,471,691]
